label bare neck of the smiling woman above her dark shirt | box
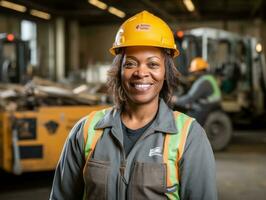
[121,101,159,129]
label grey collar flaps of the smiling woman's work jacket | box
[95,99,178,134]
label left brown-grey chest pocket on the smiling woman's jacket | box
[83,158,110,200]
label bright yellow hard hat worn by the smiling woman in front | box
[110,11,179,57]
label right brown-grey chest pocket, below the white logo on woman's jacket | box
[128,162,167,200]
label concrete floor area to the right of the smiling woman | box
[215,130,266,200]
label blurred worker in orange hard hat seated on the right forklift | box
[172,57,221,125]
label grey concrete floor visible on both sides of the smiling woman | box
[0,129,266,200]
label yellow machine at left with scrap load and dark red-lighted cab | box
[0,34,109,174]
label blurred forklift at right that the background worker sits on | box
[176,28,266,150]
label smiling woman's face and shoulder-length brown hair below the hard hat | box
[108,46,179,128]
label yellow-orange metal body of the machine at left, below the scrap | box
[0,106,106,174]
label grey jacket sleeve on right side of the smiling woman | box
[179,121,217,200]
